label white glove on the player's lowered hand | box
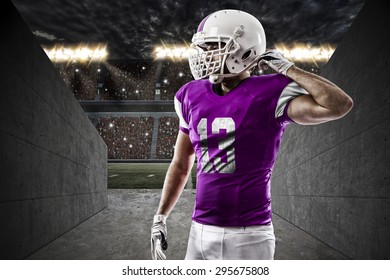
[150,215,168,260]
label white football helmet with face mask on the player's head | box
[188,10,266,83]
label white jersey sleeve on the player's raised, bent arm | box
[275,82,309,124]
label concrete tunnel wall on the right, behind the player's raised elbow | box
[272,1,390,259]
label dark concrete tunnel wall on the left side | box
[0,1,107,259]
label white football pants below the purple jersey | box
[185,221,275,260]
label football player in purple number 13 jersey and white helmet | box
[151,10,353,259]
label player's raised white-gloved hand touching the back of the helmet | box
[258,50,294,76]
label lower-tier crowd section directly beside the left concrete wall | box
[96,116,154,159]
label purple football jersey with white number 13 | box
[175,74,306,227]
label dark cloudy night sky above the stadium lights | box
[12,0,364,59]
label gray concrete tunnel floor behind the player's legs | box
[28,189,346,260]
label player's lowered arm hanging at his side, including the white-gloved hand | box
[150,130,194,260]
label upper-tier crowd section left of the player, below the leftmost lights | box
[55,60,163,100]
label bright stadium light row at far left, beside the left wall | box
[43,44,108,63]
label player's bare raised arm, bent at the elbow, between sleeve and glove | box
[287,66,353,125]
